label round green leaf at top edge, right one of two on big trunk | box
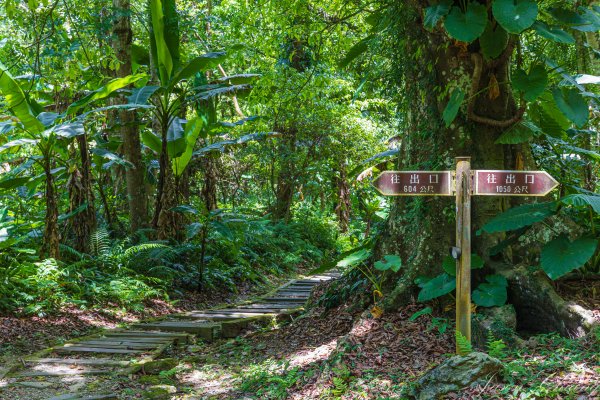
[492,0,538,33]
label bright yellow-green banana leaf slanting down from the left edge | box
[0,63,44,134]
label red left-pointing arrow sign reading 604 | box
[373,171,452,196]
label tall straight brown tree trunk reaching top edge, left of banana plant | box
[113,0,148,233]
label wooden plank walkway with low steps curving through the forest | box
[0,273,338,400]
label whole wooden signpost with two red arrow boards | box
[373,157,558,352]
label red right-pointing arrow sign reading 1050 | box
[473,170,558,196]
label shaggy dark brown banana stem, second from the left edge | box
[68,135,97,252]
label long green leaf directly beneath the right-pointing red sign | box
[482,201,557,233]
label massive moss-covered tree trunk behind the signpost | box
[375,0,583,333]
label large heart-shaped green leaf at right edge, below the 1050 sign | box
[540,235,598,280]
